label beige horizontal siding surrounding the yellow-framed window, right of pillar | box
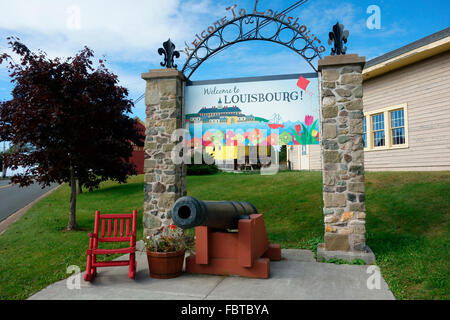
[363,51,450,171]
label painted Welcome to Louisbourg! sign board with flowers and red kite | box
[185,73,320,147]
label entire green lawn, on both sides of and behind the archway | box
[0,172,450,299]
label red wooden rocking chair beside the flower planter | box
[84,210,137,281]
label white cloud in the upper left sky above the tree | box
[0,0,224,62]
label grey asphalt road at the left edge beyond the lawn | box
[0,180,58,221]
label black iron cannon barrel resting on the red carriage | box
[172,197,258,229]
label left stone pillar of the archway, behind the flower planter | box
[142,69,186,236]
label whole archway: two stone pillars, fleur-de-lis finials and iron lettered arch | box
[142,1,374,263]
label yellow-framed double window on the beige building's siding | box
[362,104,408,151]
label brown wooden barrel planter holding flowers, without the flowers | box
[147,250,186,279]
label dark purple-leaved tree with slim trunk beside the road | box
[0,38,143,230]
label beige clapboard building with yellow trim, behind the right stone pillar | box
[288,28,450,171]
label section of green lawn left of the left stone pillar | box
[0,176,143,299]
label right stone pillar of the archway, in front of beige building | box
[317,54,375,264]
